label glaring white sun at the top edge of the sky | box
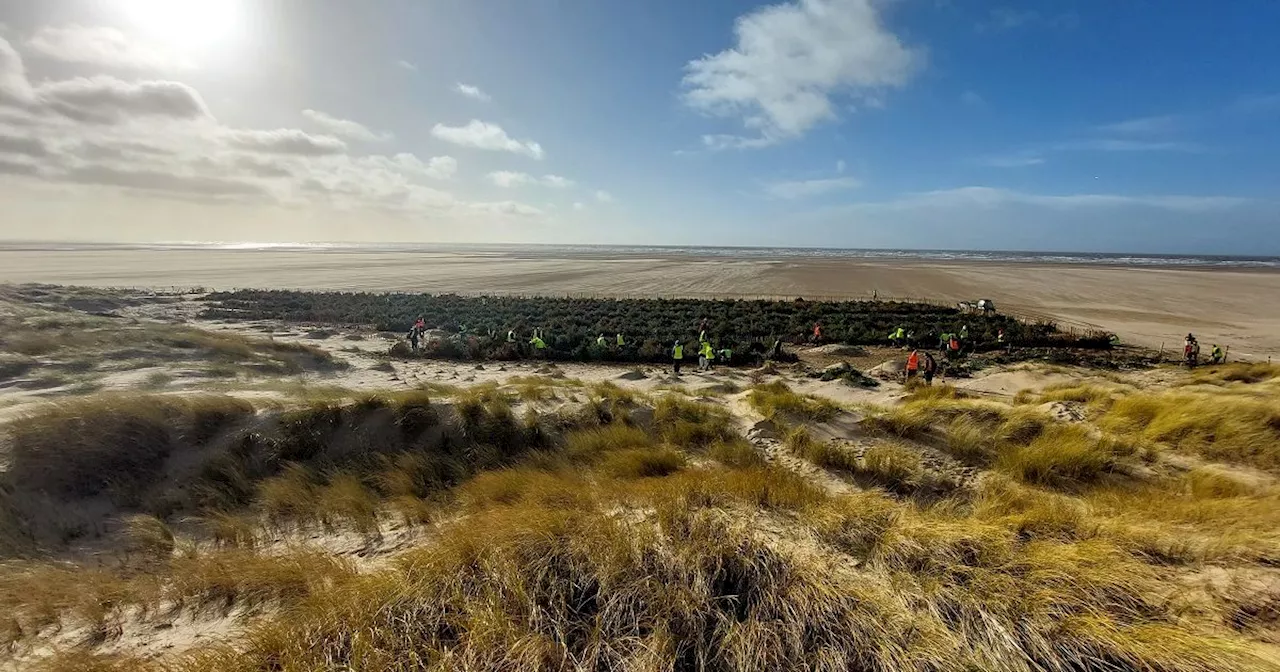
[116,0,242,47]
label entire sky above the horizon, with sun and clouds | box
[0,0,1280,255]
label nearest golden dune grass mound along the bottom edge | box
[112,472,1271,672]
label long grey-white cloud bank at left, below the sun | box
[0,38,543,220]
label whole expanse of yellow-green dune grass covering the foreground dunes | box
[0,368,1280,672]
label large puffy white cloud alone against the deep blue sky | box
[682,0,923,148]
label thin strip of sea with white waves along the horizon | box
[0,241,1280,270]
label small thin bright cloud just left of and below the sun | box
[27,24,192,70]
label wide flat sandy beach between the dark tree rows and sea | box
[0,250,1280,360]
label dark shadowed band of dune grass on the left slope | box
[0,390,562,556]
